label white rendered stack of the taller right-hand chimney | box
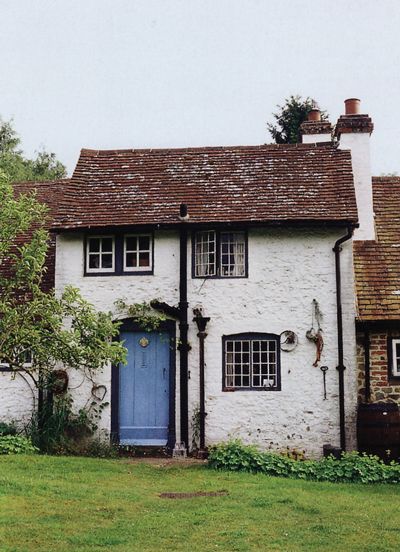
[339,132,375,240]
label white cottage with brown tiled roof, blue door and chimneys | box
[0,101,392,456]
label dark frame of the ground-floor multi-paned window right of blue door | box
[222,332,281,392]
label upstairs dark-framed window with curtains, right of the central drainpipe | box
[193,230,247,278]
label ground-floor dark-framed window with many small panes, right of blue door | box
[222,333,281,391]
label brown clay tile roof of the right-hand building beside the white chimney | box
[354,177,400,321]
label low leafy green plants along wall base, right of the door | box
[208,440,400,483]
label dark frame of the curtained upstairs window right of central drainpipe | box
[192,227,249,280]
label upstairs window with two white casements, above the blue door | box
[85,233,154,276]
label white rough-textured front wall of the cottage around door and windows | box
[52,225,357,456]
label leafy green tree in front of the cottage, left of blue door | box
[0,174,126,444]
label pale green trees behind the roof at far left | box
[0,118,67,182]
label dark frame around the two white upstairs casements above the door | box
[83,229,154,277]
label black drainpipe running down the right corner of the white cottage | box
[333,226,353,451]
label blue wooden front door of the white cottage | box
[119,331,170,446]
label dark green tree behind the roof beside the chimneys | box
[267,96,328,144]
